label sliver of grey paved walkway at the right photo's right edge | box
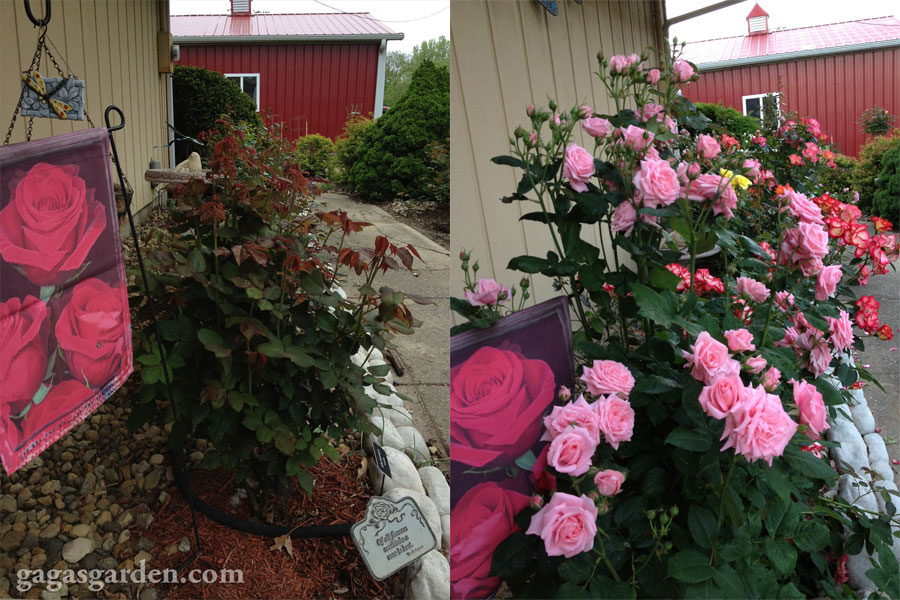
[851,263,900,468]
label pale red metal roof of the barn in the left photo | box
[170,13,403,43]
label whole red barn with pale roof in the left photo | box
[171,0,403,139]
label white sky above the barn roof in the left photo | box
[169,0,450,53]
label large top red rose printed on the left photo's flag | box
[0,163,106,286]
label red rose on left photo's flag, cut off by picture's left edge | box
[0,296,50,416]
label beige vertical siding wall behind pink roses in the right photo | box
[450,0,660,316]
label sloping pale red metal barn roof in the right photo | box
[684,17,900,65]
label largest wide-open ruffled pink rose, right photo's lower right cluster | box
[722,386,797,467]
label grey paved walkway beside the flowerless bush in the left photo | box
[320,193,450,458]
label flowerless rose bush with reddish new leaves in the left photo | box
[130,120,426,491]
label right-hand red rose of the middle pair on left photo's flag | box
[56,278,129,388]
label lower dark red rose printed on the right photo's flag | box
[450,481,530,599]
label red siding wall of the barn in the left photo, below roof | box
[176,40,380,139]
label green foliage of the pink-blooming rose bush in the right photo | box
[488,43,900,598]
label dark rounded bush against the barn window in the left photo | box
[172,65,262,160]
